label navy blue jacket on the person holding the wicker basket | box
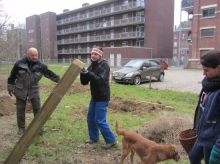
[194,90,220,148]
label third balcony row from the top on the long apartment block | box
[57,31,145,45]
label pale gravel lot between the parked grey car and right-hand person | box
[111,68,204,94]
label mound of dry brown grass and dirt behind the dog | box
[136,113,193,156]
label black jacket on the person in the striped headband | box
[80,59,110,101]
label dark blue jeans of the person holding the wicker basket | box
[189,139,212,164]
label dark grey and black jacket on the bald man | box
[8,57,60,100]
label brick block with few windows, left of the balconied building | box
[26,12,58,59]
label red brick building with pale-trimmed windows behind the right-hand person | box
[181,0,220,67]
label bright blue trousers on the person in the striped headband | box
[87,99,115,144]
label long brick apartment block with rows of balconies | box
[56,0,174,66]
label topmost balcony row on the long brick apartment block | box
[57,1,145,26]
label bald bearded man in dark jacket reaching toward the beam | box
[8,48,60,135]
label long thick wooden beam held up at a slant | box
[4,59,85,164]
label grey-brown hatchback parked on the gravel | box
[113,59,165,85]
